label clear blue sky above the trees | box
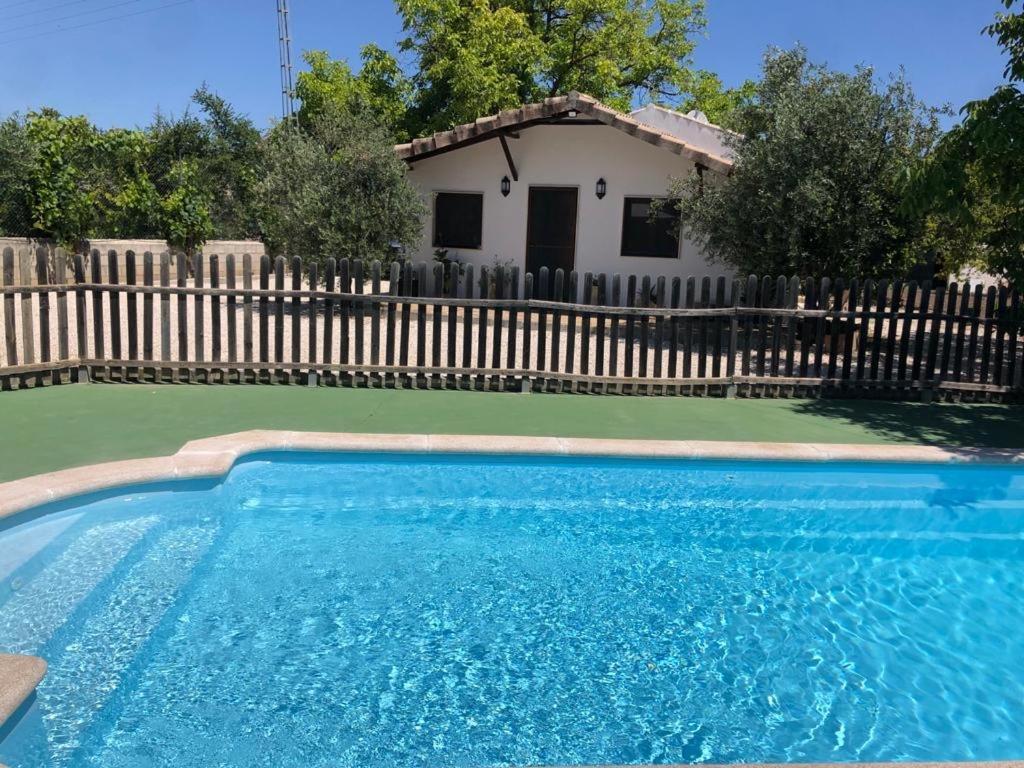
[0,0,1002,131]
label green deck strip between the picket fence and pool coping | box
[0,384,1024,482]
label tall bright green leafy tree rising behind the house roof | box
[396,0,705,130]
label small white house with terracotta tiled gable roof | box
[395,92,731,286]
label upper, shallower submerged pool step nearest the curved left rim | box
[0,517,157,653]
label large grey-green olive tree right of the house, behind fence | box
[673,48,945,278]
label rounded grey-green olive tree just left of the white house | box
[259,110,424,262]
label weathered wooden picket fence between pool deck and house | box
[0,249,1022,399]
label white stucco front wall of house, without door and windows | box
[409,125,726,286]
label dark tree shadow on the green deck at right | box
[793,399,1024,449]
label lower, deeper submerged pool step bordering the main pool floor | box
[38,525,217,766]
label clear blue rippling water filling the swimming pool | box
[0,454,1024,768]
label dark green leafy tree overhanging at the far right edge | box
[905,0,1024,287]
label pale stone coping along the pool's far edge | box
[0,430,1024,519]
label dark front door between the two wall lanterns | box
[526,186,579,281]
